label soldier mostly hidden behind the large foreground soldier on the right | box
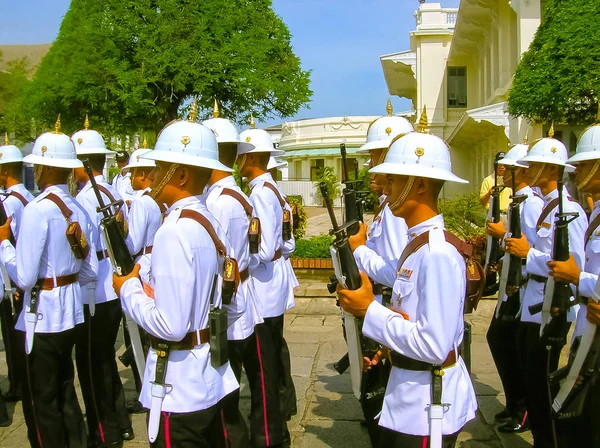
[349,100,413,447]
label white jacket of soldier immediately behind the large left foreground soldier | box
[206,176,263,341]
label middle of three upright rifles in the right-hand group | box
[496,167,527,321]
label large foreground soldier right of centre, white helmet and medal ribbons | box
[338,129,477,448]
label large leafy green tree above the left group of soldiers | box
[17,0,312,135]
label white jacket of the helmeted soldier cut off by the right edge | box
[574,201,600,337]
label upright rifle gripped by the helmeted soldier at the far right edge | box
[529,175,579,347]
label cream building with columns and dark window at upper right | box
[380,0,583,197]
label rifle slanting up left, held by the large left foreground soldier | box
[83,159,135,277]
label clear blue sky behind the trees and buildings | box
[0,0,460,125]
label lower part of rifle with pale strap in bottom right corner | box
[550,276,600,420]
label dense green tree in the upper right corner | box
[508,0,600,124]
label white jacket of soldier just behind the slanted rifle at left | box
[75,175,127,305]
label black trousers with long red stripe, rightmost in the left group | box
[225,324,283,447]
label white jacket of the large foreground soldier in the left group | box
[120,196,239,413]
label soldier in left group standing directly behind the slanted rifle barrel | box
[71,116,134,445]
